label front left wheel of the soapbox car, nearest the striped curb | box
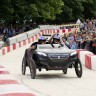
[29,59,36,79]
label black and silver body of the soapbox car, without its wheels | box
[33,44,78,70]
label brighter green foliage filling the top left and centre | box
[0,0,64,24]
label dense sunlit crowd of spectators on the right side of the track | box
[63,18,96,54]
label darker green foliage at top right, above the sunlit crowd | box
[55,0,96,23]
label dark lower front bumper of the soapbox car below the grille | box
[40,56,78,69]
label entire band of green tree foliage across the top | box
[0,0,96,24]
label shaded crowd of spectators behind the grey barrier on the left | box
[0,23,36,42]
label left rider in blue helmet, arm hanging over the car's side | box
[25,36,46,58]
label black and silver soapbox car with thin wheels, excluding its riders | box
[22,44,82,79]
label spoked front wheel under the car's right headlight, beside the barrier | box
[74,59,82,78]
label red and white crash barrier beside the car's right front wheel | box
[77,49,96,70]
